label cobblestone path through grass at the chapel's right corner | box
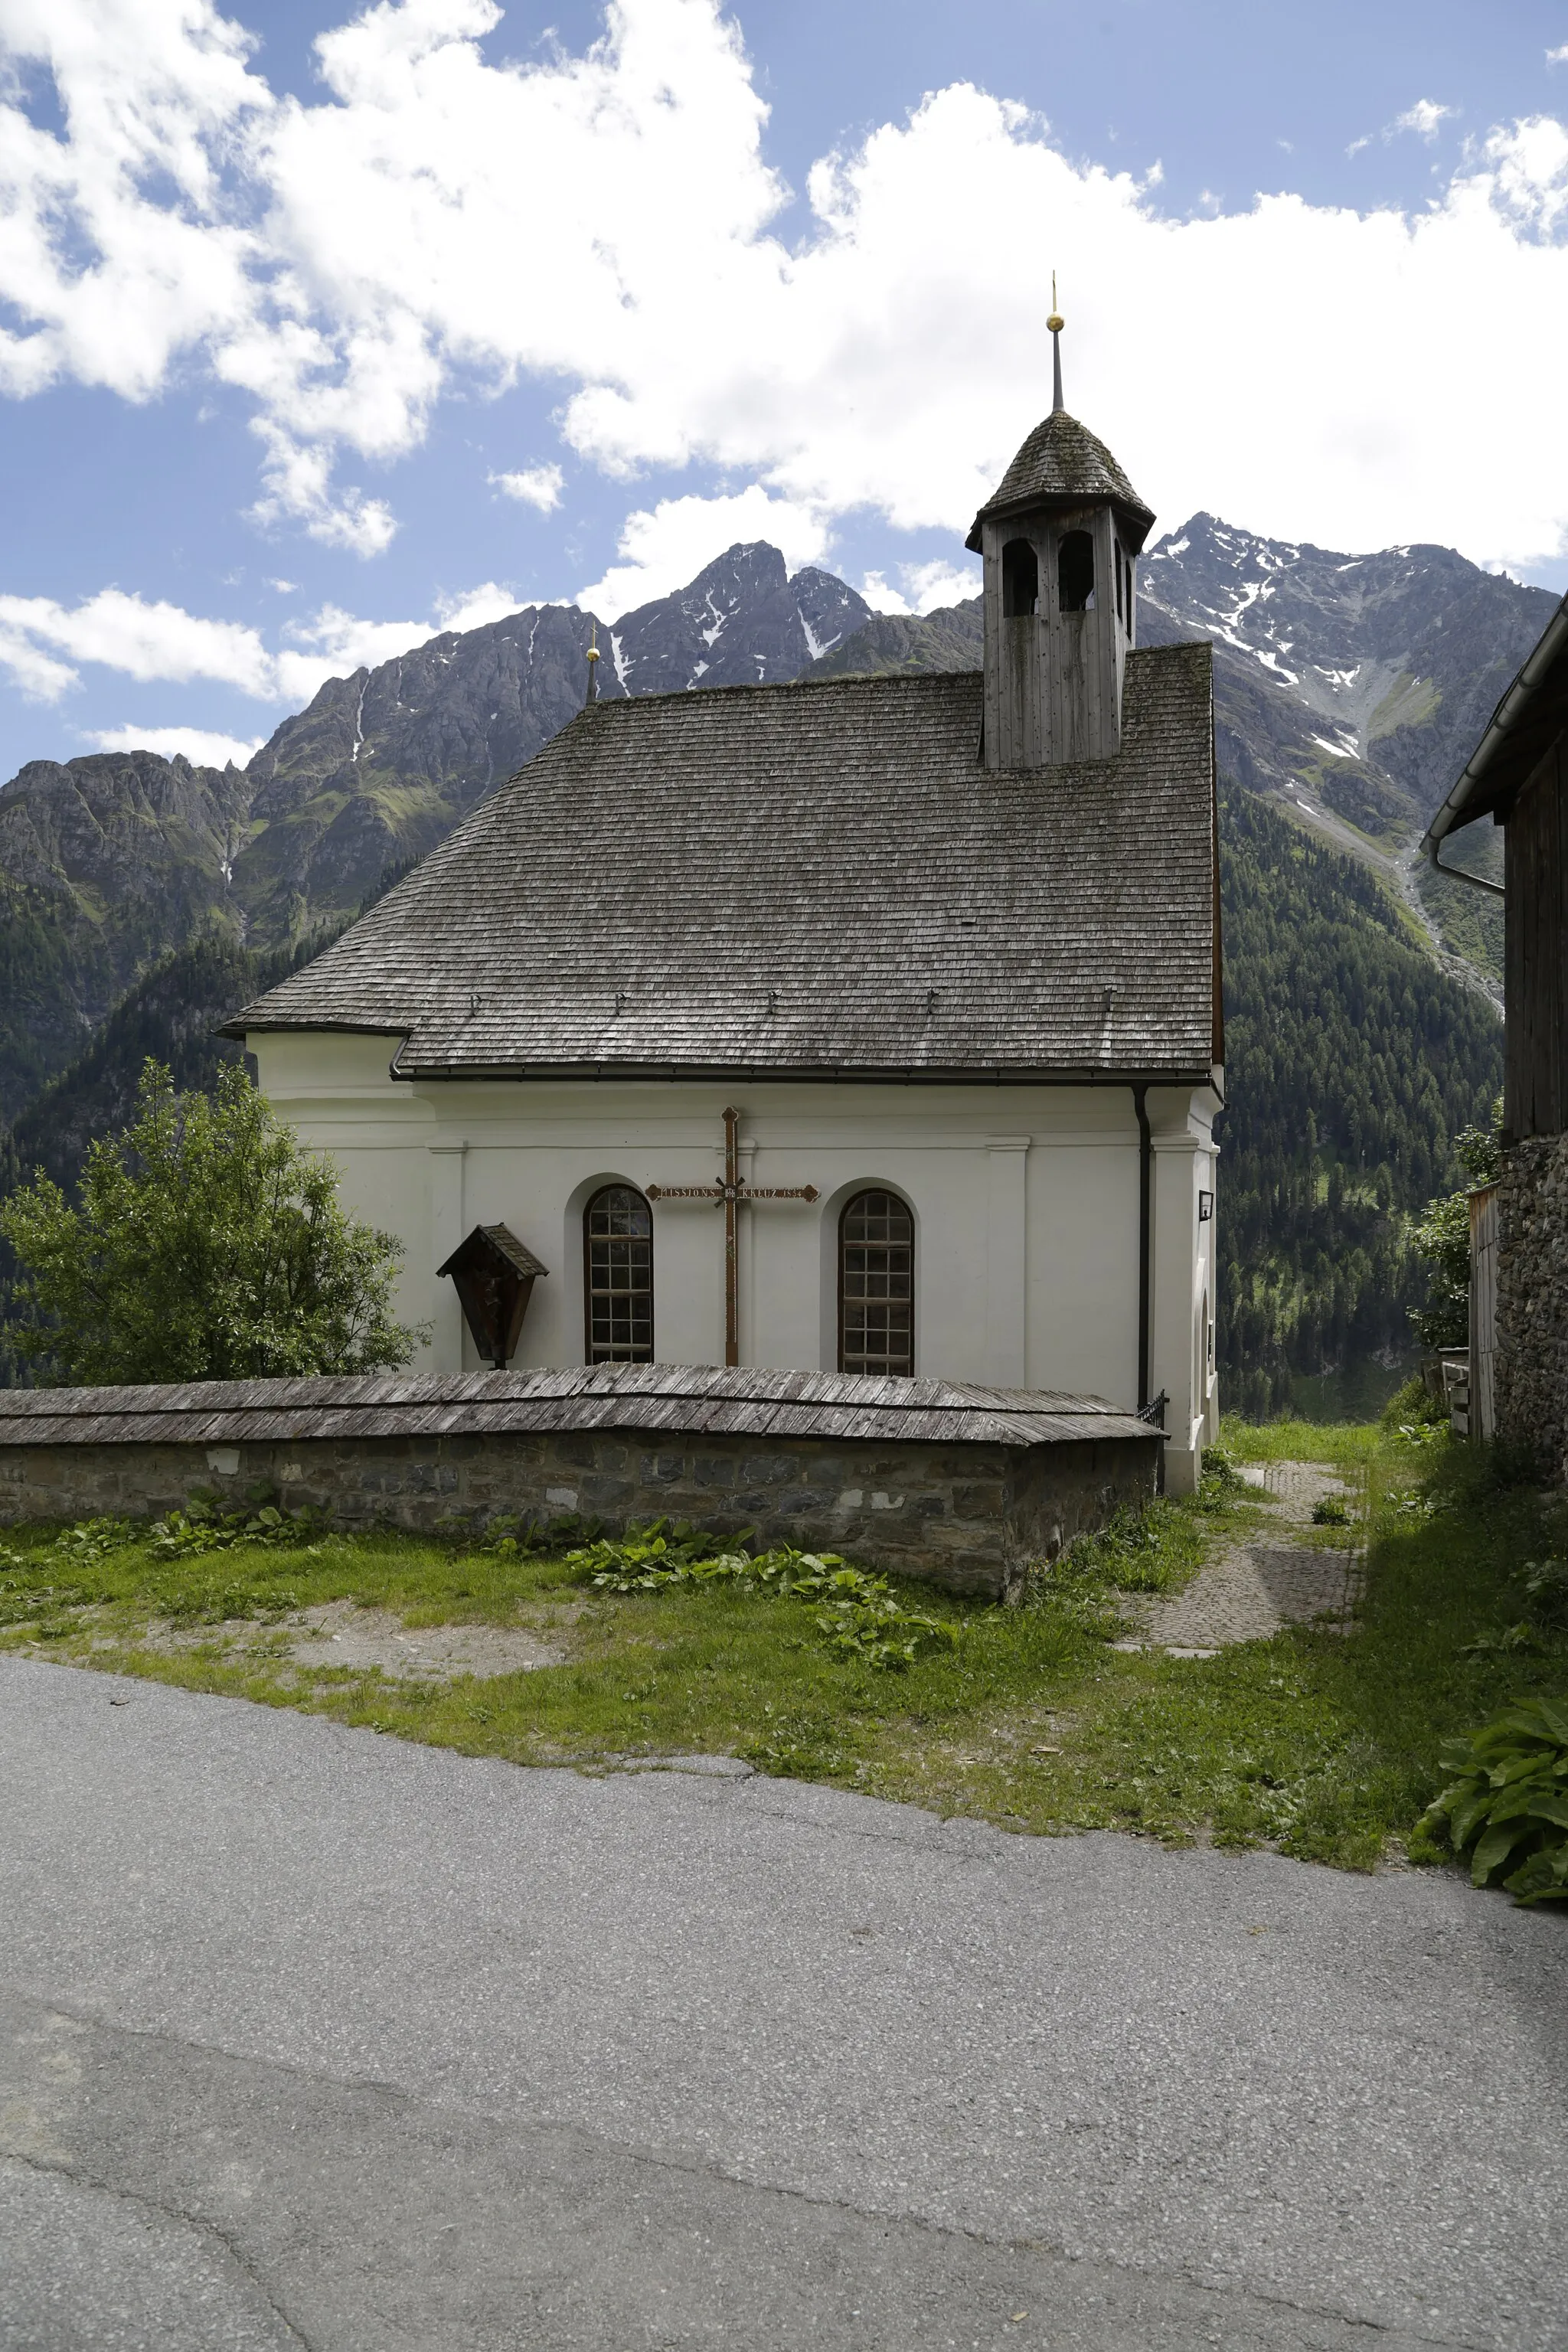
[1116,1463,1361,1658]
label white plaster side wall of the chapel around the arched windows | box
[247,1033,1215,1484]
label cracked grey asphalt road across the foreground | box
[0,1658,1568,2352]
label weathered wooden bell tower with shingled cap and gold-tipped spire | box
[966,311,1155,766]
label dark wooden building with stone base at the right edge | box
[1423,583,1568,1479]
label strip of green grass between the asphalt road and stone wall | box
[0,1423,1568,1870]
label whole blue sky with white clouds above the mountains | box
[0,0,1568,776]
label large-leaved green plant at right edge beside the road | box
[1417,1698,1568,1903]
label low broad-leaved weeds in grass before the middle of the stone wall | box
[567,1520,959,1672]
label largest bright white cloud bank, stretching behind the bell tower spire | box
[0,0,1568,573]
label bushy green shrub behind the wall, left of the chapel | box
[0,1060,416,1383]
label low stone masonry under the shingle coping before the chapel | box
[0,1430,1159,1597]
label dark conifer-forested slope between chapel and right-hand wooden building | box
[1218,781,1502,1413]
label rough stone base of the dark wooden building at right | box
[1493,1136,1568,1479]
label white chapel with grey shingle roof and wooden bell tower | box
[230,338,1225,1491]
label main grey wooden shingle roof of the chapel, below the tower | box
[228,645,1215,1080]
